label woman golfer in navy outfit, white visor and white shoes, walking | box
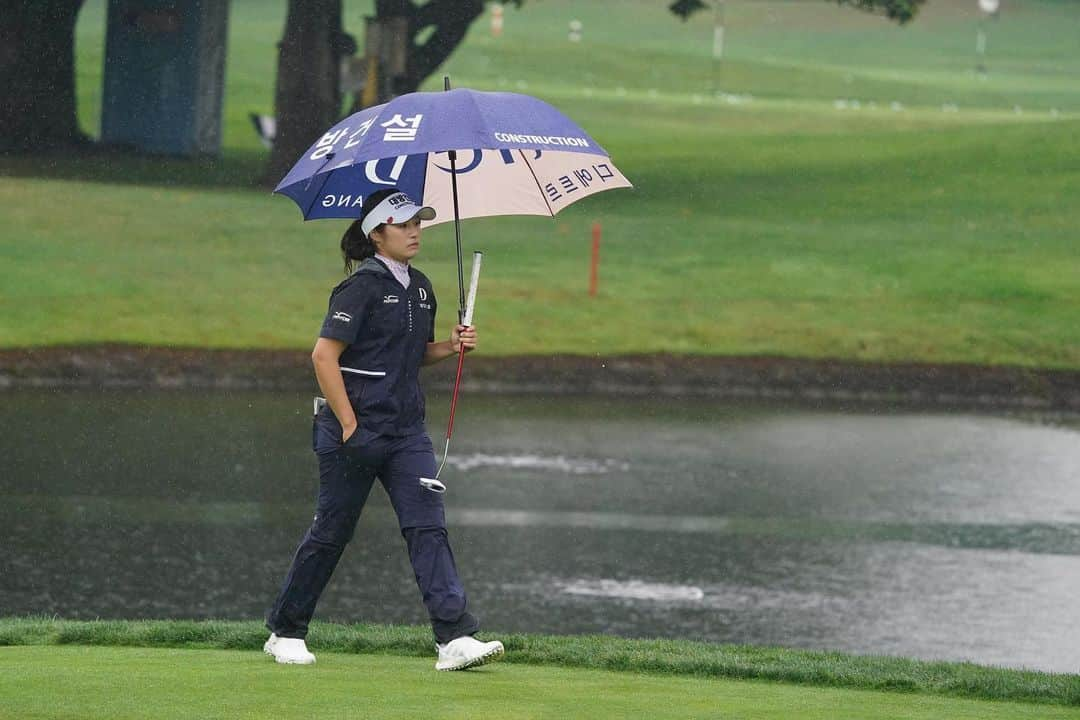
[264,190,503,670]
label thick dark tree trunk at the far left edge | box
[0,0,90,152]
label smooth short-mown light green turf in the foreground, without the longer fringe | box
[0,647,1080,720]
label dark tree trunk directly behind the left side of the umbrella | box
[265,0,341,185]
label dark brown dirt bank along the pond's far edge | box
[0,344,1080,412]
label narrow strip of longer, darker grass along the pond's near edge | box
[0,617,1080,717]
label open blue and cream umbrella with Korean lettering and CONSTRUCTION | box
[274,80,631,492]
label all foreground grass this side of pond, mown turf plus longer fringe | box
[0,617,1080,718]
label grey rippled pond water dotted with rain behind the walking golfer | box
[0,391,1080,673]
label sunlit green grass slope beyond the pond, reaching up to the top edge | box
[0,0,1080,368]
